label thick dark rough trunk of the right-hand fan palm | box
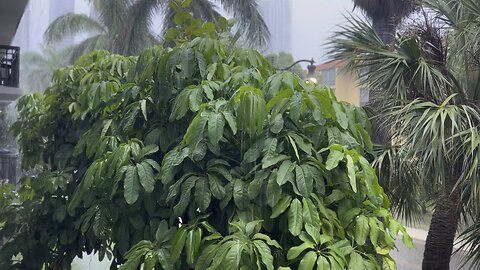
[422,178,460,270]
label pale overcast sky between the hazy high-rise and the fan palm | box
[292,0,360,63]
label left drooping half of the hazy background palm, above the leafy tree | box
[44,0,158,61]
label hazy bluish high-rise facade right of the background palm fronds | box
[258,0,292,53]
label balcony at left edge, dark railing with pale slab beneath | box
[0,45,21,106]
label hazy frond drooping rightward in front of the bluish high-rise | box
[220,0,270,48]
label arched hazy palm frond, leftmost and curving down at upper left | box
[44,13,106,44]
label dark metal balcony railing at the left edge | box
[0,45,20,87]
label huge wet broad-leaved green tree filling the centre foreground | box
[0,9,411,269]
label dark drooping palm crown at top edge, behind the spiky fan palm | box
[353,0,417,44]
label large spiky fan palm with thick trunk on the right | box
[330,0,480,270]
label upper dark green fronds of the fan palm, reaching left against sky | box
[328,16,456,102]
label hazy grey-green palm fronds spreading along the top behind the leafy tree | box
[45,0,270,60]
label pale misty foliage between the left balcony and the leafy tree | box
[20,47,70,93]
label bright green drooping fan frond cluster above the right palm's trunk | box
[387,97,480,193]
